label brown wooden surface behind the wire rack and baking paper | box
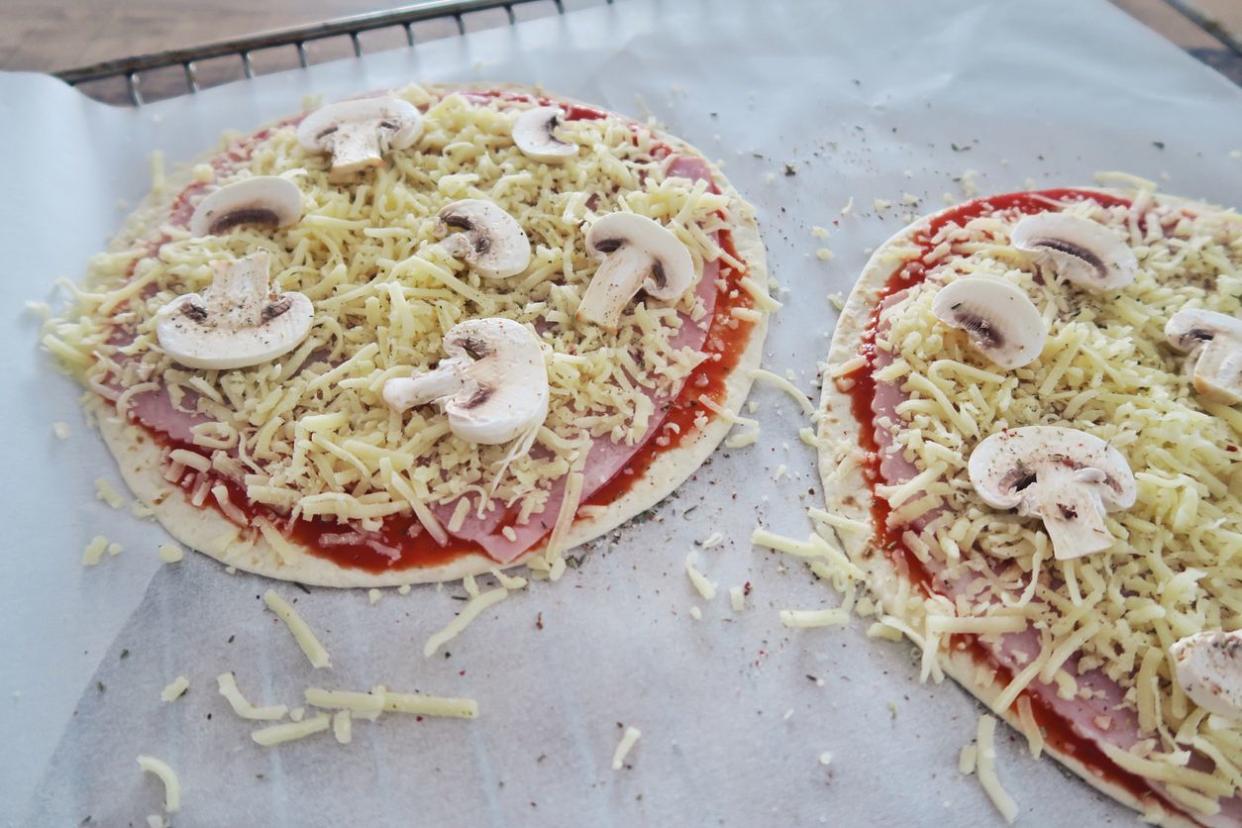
[0,0,1242,103]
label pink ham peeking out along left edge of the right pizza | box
[871,273,1242,826]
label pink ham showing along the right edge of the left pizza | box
[435,156,720,564]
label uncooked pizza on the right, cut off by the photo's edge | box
[812,187,1242,826]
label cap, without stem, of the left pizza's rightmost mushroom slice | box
[586,212,694,302]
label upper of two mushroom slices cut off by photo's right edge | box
[1165,308,1242,405]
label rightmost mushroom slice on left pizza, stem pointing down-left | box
[575,212,694,330]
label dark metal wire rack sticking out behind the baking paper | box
[56,0,614,107]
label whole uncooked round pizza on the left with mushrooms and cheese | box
[45,86,774,587]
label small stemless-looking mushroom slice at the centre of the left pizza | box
[440,199,530,279]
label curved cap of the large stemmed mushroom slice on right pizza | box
[968,426,1138,511]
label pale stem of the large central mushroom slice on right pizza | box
[1023,468,1117,560]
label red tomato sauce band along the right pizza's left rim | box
[846,189,1154,801]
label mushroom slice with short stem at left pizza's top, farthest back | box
[298,98,422,181]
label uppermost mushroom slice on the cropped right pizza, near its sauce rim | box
[1010,212,1139,290]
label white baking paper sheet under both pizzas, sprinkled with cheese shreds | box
[0,0,1242,826]
